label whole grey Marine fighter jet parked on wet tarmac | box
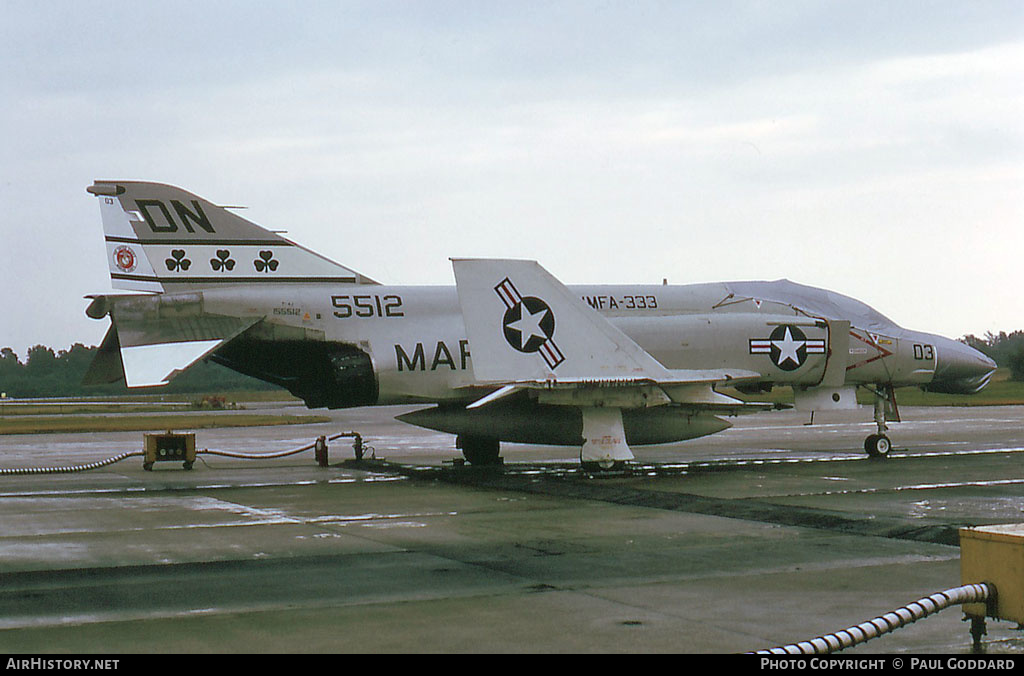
[87,180,994,465]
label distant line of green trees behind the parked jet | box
[0,331,1024,398]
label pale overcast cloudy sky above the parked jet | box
[0,0,1024,358]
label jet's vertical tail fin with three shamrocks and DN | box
[86,180,376,293]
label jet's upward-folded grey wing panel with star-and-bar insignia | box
[452,259,761,410]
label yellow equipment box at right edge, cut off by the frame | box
[959,523,1024,625]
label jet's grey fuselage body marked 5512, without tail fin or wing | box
[193,276,990,404]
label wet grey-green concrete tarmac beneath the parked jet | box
[0,407,1024,654]
